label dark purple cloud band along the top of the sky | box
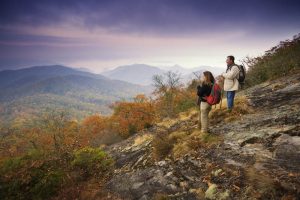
[0,0,300,35]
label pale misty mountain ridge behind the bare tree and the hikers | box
[102,64,224,85]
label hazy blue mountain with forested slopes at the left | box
[0,65,151,123]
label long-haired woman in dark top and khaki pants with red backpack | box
[197,71,221,133]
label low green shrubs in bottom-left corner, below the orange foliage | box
[0,148,113,199]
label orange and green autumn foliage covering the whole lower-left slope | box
[0,89,192,199]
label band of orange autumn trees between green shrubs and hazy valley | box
[0,95,156,158]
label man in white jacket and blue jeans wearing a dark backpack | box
[222,56,239,111]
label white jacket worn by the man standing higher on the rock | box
[222,65,240,91]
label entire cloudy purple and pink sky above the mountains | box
[0,0,300,73]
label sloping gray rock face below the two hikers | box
[102,74,300,199]
